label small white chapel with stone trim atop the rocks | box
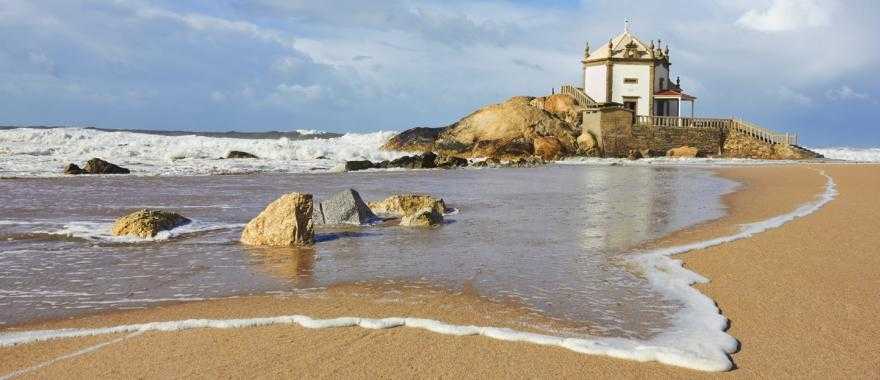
[581,21,697,117]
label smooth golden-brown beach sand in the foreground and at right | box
[0,164,880,378]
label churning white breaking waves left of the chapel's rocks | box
[0,128,402,177]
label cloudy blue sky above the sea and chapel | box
[0,0,880,147]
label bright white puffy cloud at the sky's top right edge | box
[736,0,834,32]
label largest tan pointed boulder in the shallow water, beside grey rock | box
[241,193,315,247]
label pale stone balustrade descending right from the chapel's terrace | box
[635,116,798,145]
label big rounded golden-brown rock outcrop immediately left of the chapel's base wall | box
[384,95,580,159]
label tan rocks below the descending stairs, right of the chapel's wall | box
[722,130,822,160]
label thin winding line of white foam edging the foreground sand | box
[0,172,837,371]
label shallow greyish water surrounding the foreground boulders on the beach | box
[0,165,734,339]
